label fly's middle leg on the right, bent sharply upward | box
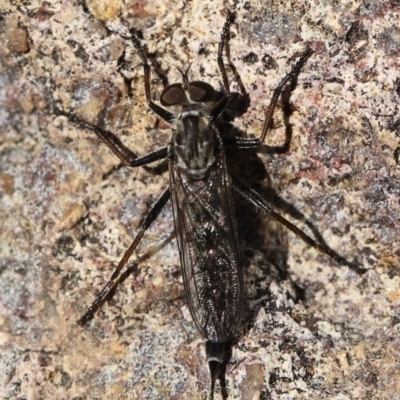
[224,47,313,149]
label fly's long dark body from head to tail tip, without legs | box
[166,82,245,392]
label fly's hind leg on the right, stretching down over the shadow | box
[231,175,365,273]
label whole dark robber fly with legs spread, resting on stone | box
[54,8,360,398]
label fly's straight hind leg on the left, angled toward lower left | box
[78,187,171,325]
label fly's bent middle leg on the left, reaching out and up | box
[53,108,168,167]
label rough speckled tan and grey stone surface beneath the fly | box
[0,0,400,400]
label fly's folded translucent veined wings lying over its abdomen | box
[170,154,244,342]
